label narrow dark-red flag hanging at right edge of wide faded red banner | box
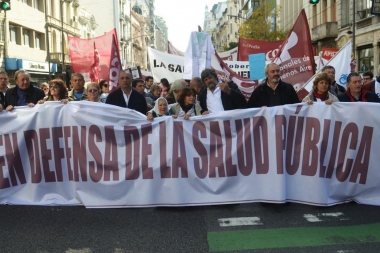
[108,34,122,92]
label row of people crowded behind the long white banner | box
[0,63,380,115]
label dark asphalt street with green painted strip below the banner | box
[0,202,380,253]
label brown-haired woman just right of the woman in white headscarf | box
[170,87,202,120]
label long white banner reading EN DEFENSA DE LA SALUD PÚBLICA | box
[0,102,380,207]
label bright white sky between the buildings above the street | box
[154,0,220,52]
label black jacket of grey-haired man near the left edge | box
[4,85,45,107]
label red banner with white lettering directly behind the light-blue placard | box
[237,38,284,61]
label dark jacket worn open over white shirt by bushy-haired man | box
[198,82,247,113]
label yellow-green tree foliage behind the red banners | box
[239,2,289,41]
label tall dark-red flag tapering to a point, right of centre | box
[273,9,315,96]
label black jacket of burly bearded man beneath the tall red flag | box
[247,80,300,108]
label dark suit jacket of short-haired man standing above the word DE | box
[106,88,148,115]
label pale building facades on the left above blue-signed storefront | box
[0,0,97,84]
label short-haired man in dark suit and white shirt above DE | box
[106,70,148,114]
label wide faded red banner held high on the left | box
[68,29,120,91]
